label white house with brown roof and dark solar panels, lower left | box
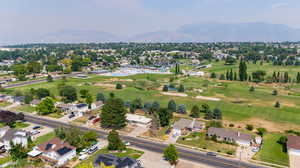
[28,138,76,166]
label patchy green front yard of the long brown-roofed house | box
[177,132,237,155]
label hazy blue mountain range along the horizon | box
[4,22,300,43]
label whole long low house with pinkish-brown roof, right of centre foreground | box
[207,127,253,146]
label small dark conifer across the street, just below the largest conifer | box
[107,130,126,151]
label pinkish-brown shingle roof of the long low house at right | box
[208,127,252,141]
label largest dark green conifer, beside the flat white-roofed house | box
[100,98,127,129]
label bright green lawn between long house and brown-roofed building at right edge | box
[254,133,289,166]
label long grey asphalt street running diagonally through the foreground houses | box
[25,114,262,168]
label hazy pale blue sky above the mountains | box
[0,0,300,42]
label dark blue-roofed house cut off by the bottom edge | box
[94,154,142,168]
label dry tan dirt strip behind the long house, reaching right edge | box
[223,118,300,132]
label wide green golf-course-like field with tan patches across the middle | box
[6,71,300,131]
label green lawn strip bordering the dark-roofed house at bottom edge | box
[77,148,144,167]
